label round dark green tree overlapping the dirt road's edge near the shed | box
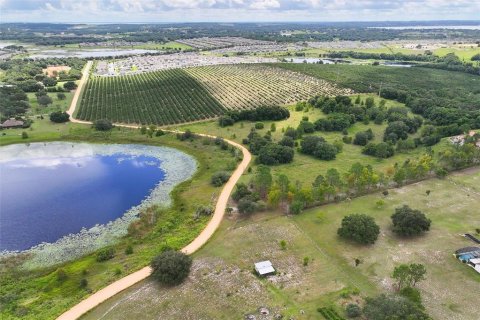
[151,250,192,286]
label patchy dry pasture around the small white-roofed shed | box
[82,167,480,320]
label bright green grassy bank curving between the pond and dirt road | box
[0,124,236,320]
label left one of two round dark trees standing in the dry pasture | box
[337,214,380,244]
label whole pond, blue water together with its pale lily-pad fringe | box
[0,142,196,264]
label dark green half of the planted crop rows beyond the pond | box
[77,69,225,125]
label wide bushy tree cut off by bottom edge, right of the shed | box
[363,294,430,320]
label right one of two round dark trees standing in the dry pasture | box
[392,205,431,237]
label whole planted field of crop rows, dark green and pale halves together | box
[77,65,351,125]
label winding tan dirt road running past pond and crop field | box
[57,61,252,320]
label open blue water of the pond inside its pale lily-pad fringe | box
[0,146,165,251]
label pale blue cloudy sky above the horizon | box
[0,0,480,23]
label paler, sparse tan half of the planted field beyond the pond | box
[186,65,351,110]
